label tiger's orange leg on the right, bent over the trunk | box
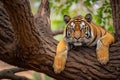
[96,33,114,64]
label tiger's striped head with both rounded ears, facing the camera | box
[64,14,92,46]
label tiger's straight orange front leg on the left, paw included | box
[53,38,68,73]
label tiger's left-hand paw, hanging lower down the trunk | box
[53,55,66,74]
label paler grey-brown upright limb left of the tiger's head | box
[35,0,52,37]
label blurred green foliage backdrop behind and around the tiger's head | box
[50,0,113,32]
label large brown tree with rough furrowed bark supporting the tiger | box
[0,0,120,80]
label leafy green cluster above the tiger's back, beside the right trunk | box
[94,0,113,33]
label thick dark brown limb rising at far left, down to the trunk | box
[1,0,43,66]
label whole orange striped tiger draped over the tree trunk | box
[53,13,115,73]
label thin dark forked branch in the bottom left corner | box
[0,68,30,80]
